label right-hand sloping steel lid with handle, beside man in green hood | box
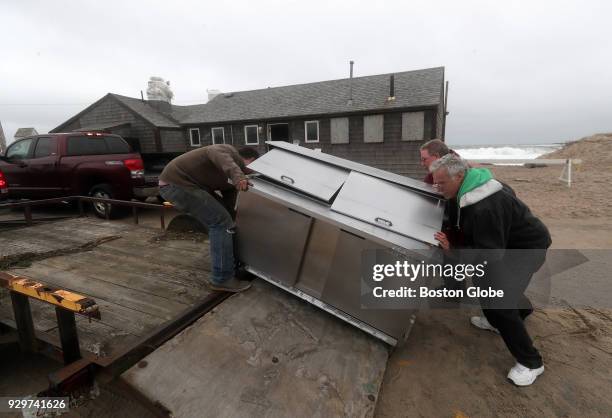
[331,171,444,245]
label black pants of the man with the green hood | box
[481,250,546,369]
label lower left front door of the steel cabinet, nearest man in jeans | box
[236,192,313,286]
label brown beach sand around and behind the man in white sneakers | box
[376,134,612,418]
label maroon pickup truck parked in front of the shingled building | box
[0,132,156,216]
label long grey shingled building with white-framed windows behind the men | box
[52,67,446,178]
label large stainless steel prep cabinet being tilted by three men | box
[236,141,444,345]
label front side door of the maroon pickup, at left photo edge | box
[2,138,34,198]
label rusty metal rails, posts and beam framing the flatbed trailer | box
[0,196,232,408]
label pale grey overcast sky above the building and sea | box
[0,0,612,144]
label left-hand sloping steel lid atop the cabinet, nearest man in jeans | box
[249,149,349,202]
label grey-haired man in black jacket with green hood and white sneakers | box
[430,154,551,386]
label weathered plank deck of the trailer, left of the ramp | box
[0,218,210,357]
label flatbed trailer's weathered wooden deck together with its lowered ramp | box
[0,217,389,417]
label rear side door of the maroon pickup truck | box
[27,136,62,198]
